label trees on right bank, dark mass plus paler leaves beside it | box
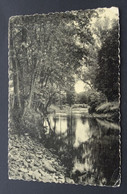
[78,14,119,101]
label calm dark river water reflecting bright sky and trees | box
[42,113,119,185]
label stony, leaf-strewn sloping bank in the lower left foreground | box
[8,131,65,183]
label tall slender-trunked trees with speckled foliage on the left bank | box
[9,11,96,123]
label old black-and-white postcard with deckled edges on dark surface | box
[8,7,121,187]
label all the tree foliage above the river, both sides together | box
[9,9,118,126]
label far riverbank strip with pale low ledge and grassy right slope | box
[49,102,119,122]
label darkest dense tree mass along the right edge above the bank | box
[95,25,119,101]
